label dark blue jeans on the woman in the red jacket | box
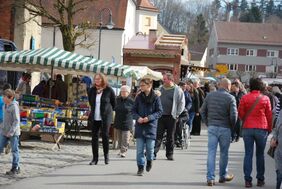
[242,129,268,182]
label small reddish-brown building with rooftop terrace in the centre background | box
[123,30,189,82]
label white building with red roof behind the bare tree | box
[41,0,158,64]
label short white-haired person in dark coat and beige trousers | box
[114,85,134,158]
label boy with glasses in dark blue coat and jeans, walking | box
[132,78,163,176]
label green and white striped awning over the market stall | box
[0,48,135,77]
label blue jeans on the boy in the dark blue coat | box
[136,137,155,166]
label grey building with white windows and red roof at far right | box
[207,22,282,81]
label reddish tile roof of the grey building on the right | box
[215,22,282,46]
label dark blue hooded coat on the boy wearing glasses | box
[132,90,163,139]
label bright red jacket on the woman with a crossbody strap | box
[239,90,272,132]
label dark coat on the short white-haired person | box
[114,96,134,131]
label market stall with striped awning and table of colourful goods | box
[0,48,162,147]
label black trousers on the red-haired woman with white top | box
[92,121,110,161]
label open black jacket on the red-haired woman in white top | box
[88,86,116,126]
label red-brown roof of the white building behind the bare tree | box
[42,0,128,29]
